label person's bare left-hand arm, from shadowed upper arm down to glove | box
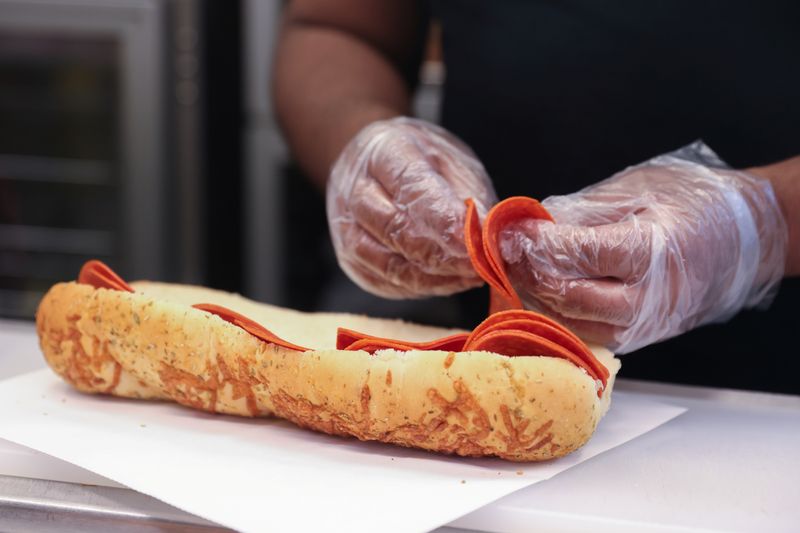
[273,0,425,186]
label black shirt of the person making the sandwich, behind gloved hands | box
[432,0,800,393]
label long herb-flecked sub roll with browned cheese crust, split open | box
[36,282,619,461]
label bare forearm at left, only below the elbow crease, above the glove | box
[273,8,409,186]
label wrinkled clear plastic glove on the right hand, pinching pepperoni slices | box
[501,142,788,353]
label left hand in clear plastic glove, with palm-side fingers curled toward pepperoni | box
[327,117,497,298]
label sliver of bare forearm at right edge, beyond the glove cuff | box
[749,156,800,277]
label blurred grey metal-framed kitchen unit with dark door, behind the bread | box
[0,0,248,318]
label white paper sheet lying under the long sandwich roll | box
[0,370,684,533]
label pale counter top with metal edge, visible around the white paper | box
[0,320,800,533]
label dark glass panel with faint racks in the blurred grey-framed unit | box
[0,30,121,317]
